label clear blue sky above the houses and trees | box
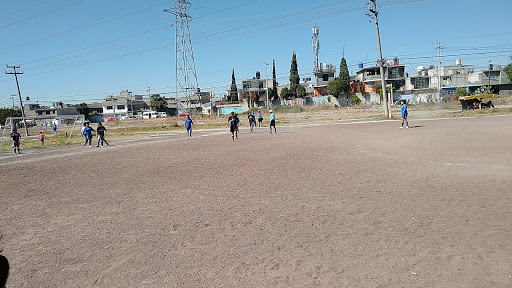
[0,0,512,107]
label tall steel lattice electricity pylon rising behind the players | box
[164,0,197,110]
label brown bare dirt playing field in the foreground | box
[0,115,512,287]
